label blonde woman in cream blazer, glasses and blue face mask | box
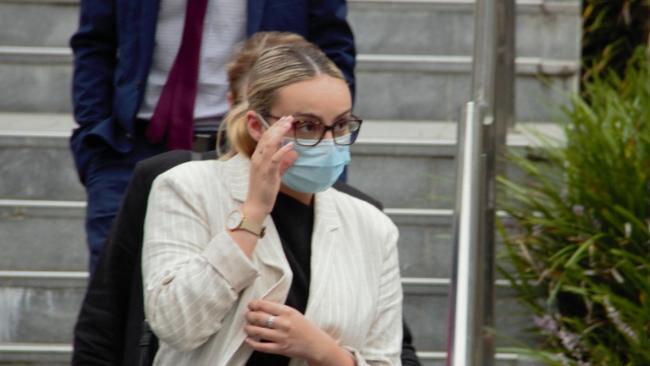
[143,38,402,366]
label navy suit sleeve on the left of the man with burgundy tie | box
[70,0,117,127]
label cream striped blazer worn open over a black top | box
[142,155,402,366]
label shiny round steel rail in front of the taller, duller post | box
[447,102,486,366]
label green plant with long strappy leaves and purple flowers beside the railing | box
[499,51,650,366]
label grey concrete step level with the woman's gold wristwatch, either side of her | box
[0,200,451,277]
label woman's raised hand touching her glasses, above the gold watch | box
[242,116,298,220]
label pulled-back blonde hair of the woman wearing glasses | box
[222,36,345,157]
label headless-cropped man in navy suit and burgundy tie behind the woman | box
[70,0,355,272]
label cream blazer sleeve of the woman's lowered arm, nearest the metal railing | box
[346,221,403,366]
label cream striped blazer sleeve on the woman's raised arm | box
[142,170,258,351]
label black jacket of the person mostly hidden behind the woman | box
[72,150,420,366]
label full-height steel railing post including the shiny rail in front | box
[447,0,515,366]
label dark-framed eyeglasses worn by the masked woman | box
[269,115,363,146]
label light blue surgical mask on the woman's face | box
[282,139,350,193]
